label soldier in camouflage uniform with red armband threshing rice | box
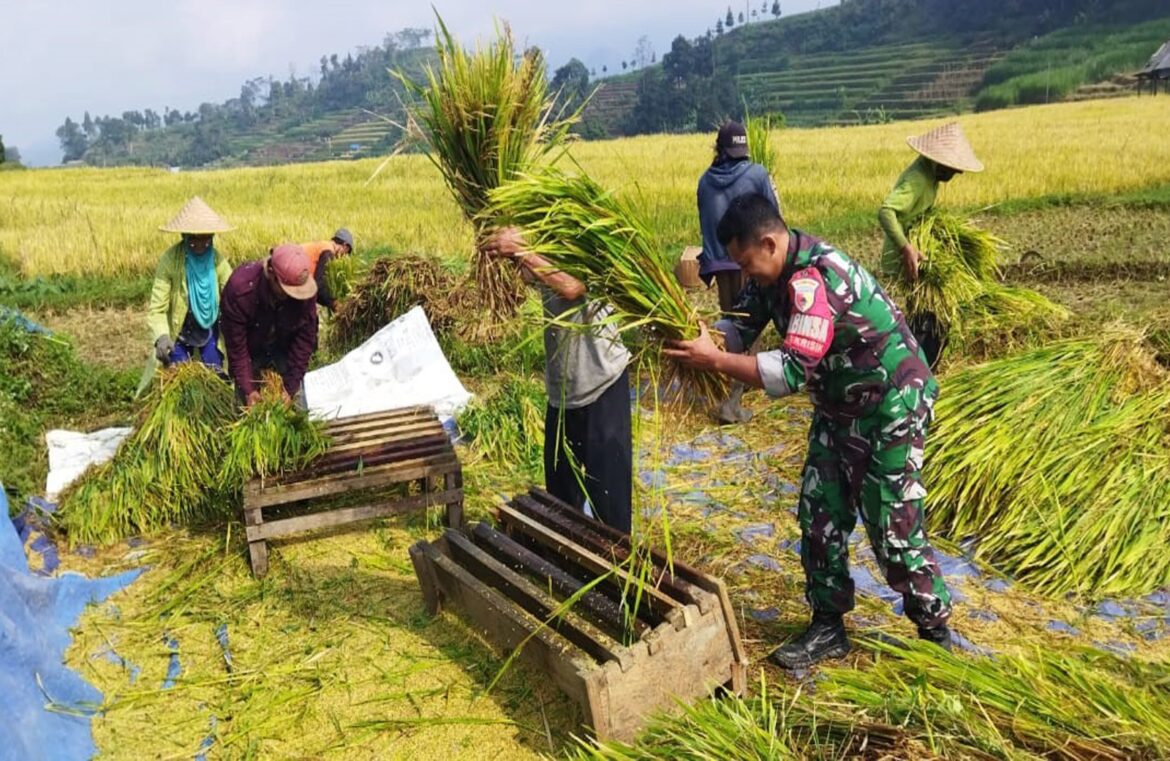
[667,196,951,669]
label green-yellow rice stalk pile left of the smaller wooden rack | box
[56,362,325,544]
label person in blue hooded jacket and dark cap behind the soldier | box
[697,122,784,424]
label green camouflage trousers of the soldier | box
[798,383,951,628]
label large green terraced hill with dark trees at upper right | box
[592,0,1170,133]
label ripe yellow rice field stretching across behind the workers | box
[0,98,1170,276]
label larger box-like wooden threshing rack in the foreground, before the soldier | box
[411,489,748,740]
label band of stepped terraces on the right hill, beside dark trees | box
[736,41,1002,126]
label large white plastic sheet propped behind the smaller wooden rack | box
[304,307,472,419]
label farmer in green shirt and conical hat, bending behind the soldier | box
[878,122,983,366]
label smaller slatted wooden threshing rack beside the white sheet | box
[243,407,463,577]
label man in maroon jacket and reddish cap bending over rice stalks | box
[220,244,317,406]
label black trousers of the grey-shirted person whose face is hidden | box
[544,370,634,534]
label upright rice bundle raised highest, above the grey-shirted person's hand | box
[398,19,578,316]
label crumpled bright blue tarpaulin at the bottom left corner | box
[0,489,140,761]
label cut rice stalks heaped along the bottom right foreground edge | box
[574,642,1170,761]
